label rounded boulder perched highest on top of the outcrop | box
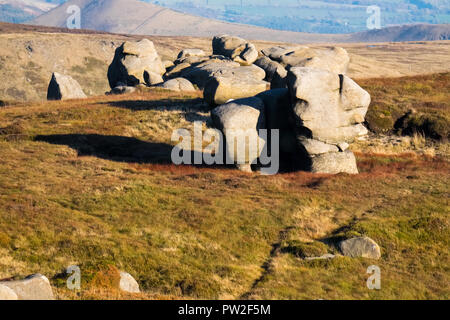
[212,35,258,66]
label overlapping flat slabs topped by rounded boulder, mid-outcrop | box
[164,35,270,107]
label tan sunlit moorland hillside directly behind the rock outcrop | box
[0,23,450,101]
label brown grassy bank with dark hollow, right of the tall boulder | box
[359,73,450,140]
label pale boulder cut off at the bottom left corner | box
[0,274,55,300]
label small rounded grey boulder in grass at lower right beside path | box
[339,237,381,260]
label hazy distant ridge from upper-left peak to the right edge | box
[31,0,450,43]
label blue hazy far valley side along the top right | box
[156,0,450,34]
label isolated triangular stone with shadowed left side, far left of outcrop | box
[47,72,86,100]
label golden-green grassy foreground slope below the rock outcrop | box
[0,80,450,299]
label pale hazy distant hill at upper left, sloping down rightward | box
[32,0,342,42]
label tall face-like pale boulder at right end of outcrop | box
[287,68,370,174]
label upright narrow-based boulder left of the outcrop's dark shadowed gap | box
[211,97,266,172]
